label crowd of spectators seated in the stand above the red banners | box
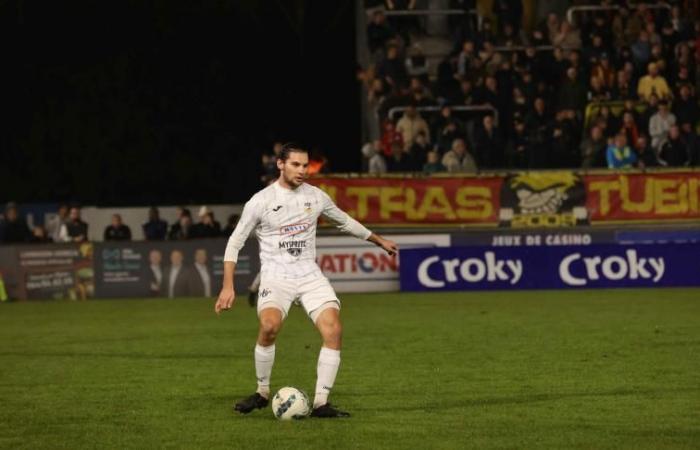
[359,0,700,174]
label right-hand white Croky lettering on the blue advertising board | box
[559,249,666,286]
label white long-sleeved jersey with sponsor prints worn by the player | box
[224,181,371,278]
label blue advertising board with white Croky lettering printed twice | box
[399,244,700,291]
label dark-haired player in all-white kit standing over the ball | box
[214,144,398,417]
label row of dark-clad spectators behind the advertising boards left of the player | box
[0,202,239,244]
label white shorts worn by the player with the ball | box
[258,272,340,323]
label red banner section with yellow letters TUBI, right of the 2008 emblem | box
[584,171,700,223]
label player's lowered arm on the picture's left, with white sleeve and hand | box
[214,199,260,314]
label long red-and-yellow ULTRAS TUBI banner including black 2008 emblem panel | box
[311,170,700,229]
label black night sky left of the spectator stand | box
[0,0,360,205]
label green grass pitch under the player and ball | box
[0,289,700,450]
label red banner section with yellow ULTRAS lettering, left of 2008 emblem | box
[310,176,503,226]
